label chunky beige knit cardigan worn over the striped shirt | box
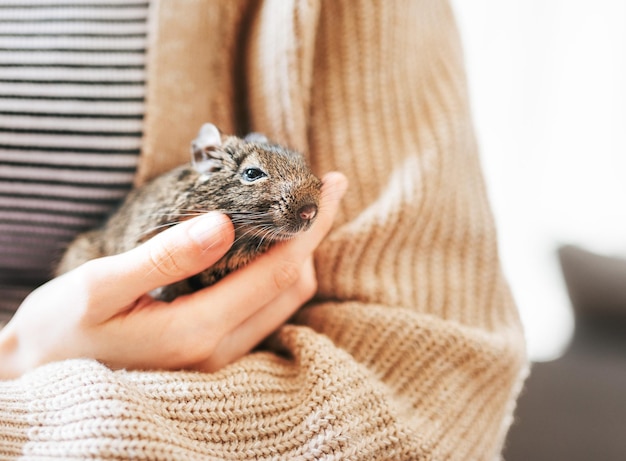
[0,0,526,460]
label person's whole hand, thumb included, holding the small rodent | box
[0,173,347,379]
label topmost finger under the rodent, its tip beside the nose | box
[179,173,347,334]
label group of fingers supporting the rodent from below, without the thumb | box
[125,174,347,371]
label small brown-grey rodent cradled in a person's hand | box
[56,123,322,301]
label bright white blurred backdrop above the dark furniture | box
[452,0,626,360]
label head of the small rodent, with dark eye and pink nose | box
[186,124,322,240]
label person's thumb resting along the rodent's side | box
[91,212,234,307]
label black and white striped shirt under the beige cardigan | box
[0,0,148,317]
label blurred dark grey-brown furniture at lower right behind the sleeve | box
[504,246,626,461]
